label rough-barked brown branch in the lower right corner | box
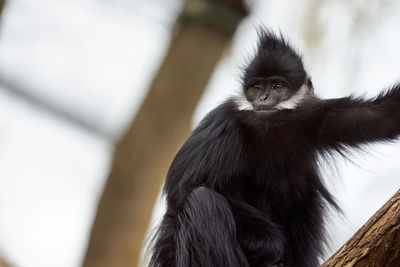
[321,190,400,267]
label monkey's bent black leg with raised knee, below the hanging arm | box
[175,187,249,267]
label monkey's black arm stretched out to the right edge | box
[317,85,400,149]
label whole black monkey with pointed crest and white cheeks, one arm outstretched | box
[150,30,400,267]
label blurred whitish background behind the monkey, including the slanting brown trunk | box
[0,0,400,267]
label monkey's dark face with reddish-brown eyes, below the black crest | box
[245,76,294,111]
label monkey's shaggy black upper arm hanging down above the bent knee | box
[164,103,244,208]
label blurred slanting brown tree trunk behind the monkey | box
[83,0,246,267]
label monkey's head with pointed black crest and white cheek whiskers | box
[236,30,313,112]
